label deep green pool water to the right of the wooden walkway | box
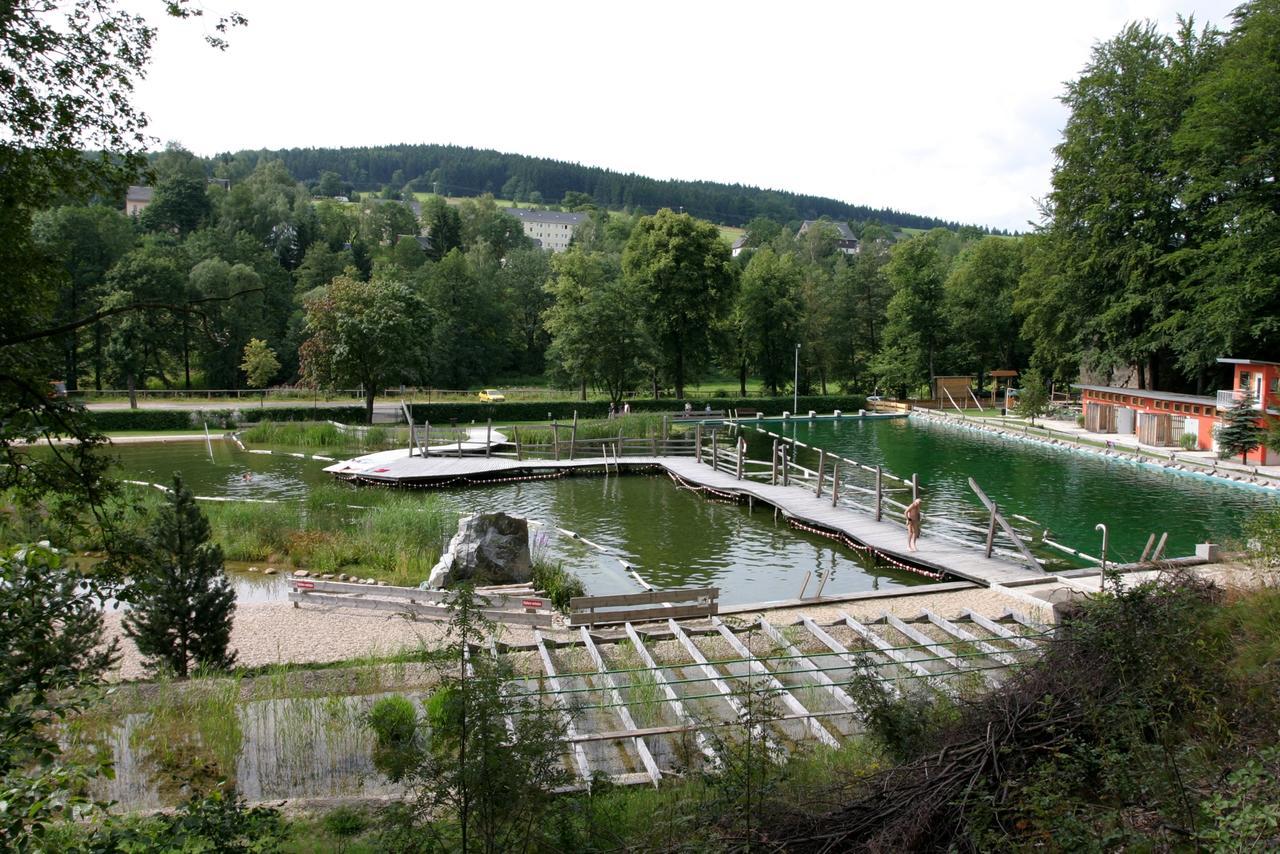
[746,419,1277,561]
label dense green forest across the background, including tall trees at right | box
[31,3,1280,414]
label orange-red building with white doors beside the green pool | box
[1075,359,1280,465]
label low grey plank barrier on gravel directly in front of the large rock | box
[289,577,554,627]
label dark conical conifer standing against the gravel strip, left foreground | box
[124,474,236,676]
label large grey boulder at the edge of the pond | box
[424,513,534,589]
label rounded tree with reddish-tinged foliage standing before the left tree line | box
[300,275,425,423]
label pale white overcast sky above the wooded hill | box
[137,0,1239,230]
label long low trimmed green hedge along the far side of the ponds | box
[82,394,867,433]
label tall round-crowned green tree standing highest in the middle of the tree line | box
[622,207,733,398]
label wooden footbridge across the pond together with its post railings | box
[325,425,1046,585]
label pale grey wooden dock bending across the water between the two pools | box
[325,431,1046,586]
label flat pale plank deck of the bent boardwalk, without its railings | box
[325,449,1047,586]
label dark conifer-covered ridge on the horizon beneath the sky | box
[202,145,977,228]
